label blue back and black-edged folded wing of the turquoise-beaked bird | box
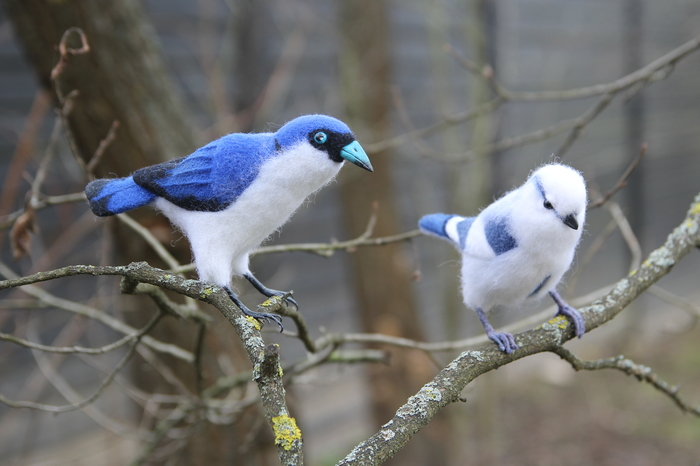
[133,133,277,212]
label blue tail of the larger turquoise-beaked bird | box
[85,177,157,217]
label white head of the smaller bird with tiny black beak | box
[527,163,587,236]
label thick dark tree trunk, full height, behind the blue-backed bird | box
[2,0,272,465]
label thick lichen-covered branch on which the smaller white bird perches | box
[338,195,700,466]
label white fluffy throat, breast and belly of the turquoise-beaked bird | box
[155,142,343,287]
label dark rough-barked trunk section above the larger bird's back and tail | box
[2,0,196,175]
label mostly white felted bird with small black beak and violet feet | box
[419,164,587,353]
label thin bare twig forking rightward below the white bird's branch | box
[552,347,700,417]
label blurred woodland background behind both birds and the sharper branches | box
[0,0,700,466]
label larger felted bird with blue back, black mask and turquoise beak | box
[85,115,373,330]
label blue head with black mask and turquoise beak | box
[275,115,374,171]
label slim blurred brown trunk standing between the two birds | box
[340,0,454,465]
